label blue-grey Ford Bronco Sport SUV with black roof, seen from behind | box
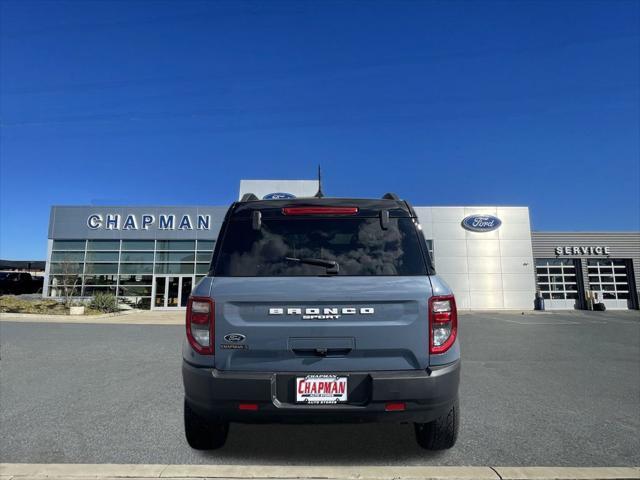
[182,194,460,450]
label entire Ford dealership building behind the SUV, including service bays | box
[43,180,640,310]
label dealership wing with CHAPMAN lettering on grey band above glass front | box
[43,206,226,309]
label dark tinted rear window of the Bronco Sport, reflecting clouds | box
[214,217,427,277]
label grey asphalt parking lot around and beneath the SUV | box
[0,311,640,466]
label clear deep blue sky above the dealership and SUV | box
[0,0,640,259]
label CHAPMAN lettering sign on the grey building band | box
[87,213,211,230]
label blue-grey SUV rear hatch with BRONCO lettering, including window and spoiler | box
[211,201,431,372]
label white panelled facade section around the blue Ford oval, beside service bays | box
[415,206,536,310]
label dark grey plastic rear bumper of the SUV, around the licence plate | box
[182,360,460,423]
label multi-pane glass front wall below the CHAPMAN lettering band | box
[48,239,215,308]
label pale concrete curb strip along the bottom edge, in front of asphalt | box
[0,463,640,480]
